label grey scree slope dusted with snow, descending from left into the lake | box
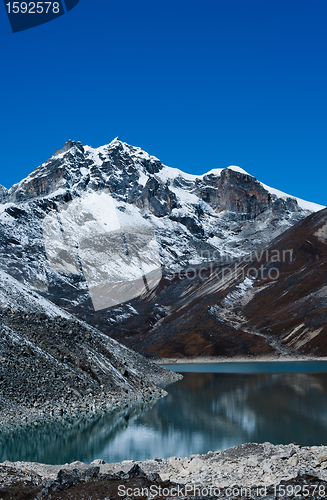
[0,271,179,423]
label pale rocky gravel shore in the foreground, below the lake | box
[0,443,327,500]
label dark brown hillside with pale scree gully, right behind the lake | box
[80,209,327,357]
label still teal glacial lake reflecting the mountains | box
[0,361,327,464]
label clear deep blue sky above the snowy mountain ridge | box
[0,0,327,205]
